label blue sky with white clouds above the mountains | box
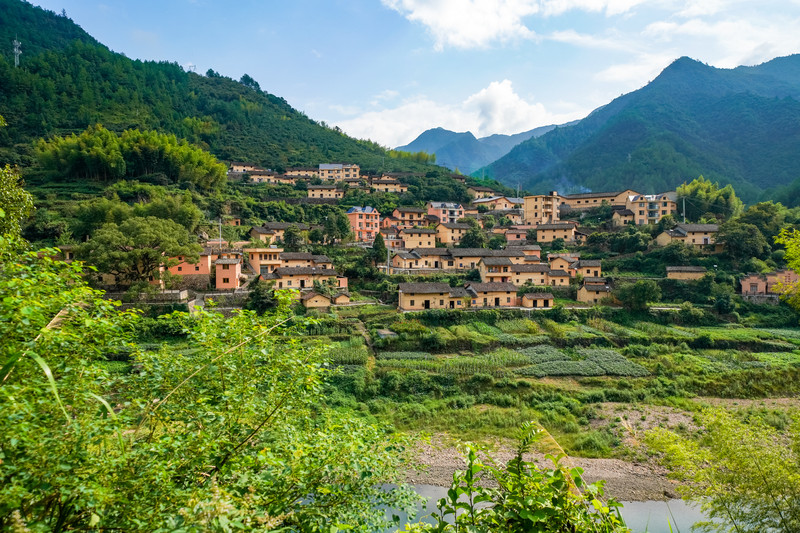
[28,0,800,148]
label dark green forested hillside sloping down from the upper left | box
[0,0,430,175]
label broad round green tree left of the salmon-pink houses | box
[78,217,202,285]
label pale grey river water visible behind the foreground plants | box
[388,485,704,533]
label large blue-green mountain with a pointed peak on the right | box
[482,55,800,201]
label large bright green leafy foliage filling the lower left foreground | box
[0,239,418,531]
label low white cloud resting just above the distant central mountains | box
[335,80,589,147]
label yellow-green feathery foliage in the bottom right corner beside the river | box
[646,409,800,533]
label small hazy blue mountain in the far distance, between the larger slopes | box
[397,126,556,172]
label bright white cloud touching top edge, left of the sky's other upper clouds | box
[382,0,539,50]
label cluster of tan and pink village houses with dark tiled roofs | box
[63,158,797,311]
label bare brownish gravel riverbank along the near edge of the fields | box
[406,439,680,501]
